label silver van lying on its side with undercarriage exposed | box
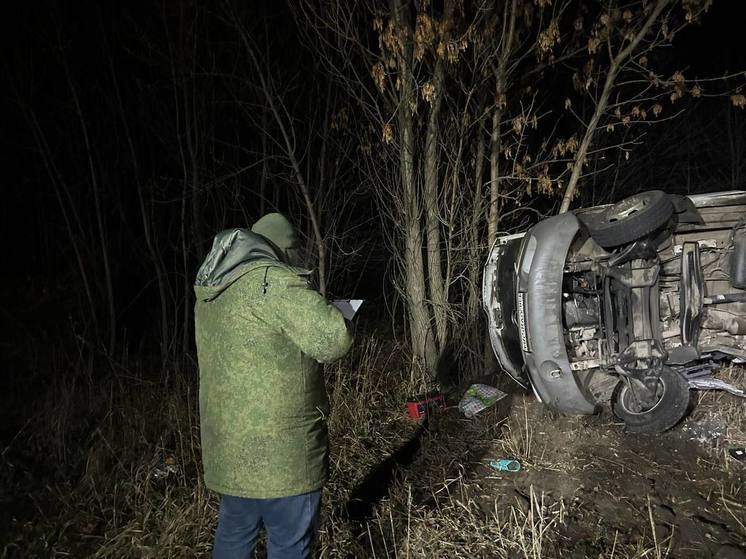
[485,191,746,431]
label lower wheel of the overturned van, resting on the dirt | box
[611,367,689,433]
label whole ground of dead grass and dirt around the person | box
[0,337,746,559]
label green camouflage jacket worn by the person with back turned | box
[195,230,352,498]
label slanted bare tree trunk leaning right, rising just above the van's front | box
[559,0,670,213]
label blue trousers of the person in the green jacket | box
[212,489,321,559]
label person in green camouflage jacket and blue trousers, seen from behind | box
[194,213,352,559]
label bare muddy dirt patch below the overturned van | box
[480,400,746,558]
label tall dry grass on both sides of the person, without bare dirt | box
[0,336,746,559]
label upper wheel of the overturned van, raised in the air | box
[585,190,674,248]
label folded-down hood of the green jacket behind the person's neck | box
[194,228,282,300]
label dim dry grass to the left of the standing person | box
[3,360,216,558]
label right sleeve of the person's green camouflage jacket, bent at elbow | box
[263,267,352,363]
